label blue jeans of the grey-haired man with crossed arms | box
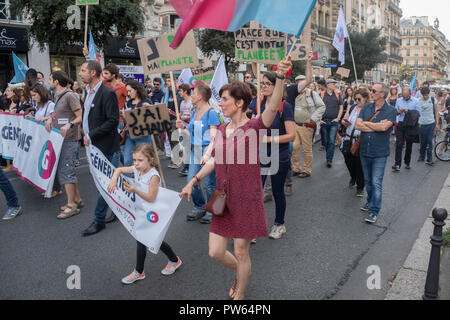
[361,156,387,215]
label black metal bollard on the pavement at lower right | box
[422,208,448,300]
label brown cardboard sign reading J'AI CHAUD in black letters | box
[123,104,172,139]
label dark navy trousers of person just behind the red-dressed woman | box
[261,159,291,225]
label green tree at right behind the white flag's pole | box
[331,28,388,81]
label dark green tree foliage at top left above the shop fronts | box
[12,0,152,53]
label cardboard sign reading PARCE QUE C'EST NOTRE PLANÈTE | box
[234,28,286,64]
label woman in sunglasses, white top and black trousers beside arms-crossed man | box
[341,89,370,197]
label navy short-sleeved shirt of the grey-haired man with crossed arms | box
[359,102,397,158]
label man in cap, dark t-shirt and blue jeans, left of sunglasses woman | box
[320,79,344,168]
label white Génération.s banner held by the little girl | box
[87,145,181,254]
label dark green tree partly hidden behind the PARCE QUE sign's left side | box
[198,29,239,73]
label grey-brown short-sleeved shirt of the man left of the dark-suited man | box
[53,90,81,141]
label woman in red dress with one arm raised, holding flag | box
[180,57,292,300]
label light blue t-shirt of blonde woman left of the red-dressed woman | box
[188,108,220,146]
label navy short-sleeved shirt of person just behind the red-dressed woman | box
[249,99,295,160]
